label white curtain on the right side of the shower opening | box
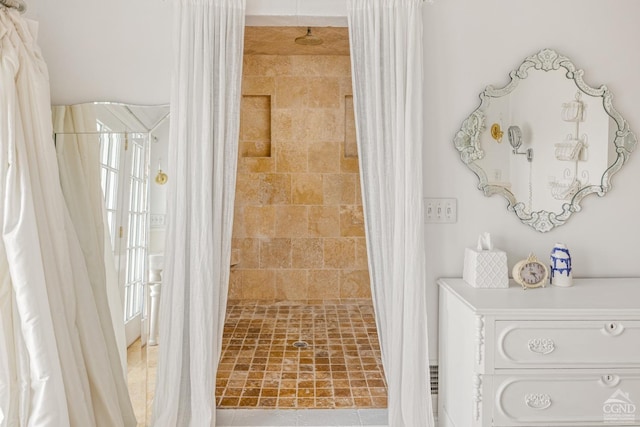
[348,0,434,427]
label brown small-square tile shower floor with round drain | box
[216,299,387,409]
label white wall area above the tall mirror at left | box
[26,0,172,105]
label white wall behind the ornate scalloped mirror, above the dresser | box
[425,0,640,360]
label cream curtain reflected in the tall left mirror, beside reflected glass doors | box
[52,104,128,378]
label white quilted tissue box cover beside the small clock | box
[462,248,509,289]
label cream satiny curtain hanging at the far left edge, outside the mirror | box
[0,8,136,427]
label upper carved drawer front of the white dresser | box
[495,320,640,368]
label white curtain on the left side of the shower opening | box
[153,0,245,427]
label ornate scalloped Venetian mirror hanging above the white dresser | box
[454,49,637,232]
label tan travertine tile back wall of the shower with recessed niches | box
[229,55,371,300]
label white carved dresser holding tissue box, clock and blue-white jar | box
[438,279,640,427]
